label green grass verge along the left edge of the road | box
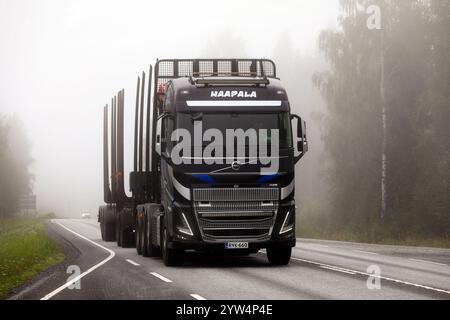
[0,217,64,298]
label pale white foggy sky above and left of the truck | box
[0,0,338,216]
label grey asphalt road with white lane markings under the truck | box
[7,220,450,300]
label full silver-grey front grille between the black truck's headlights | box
[193,188,279,241]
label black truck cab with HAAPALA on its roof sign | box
[156,60,305,264]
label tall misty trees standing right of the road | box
[308,0,450,242]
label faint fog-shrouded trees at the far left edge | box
[0,114,32,217]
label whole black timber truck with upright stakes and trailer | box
[98,59,308,266]
